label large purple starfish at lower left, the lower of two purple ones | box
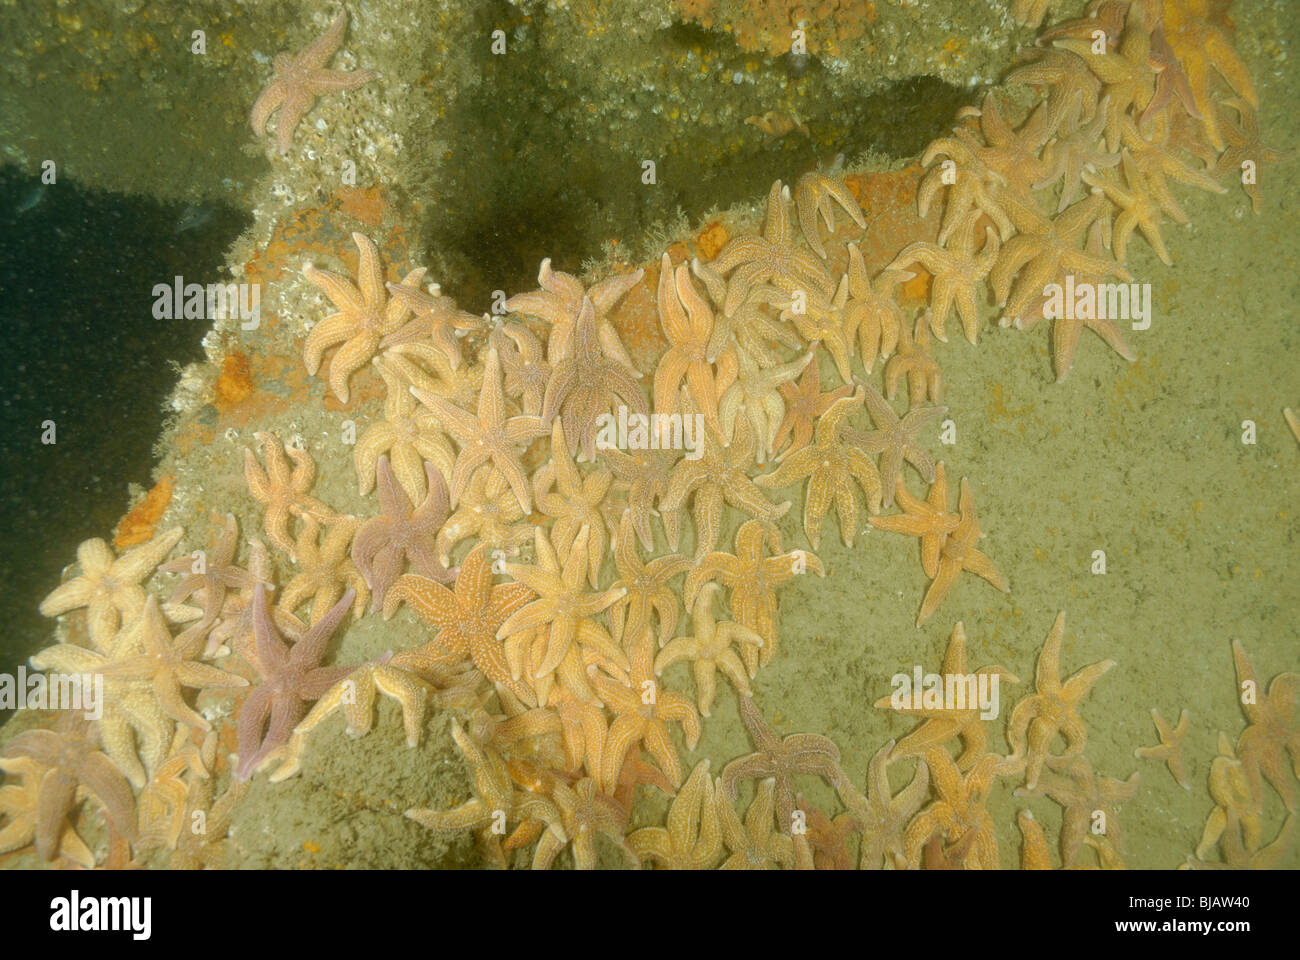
[235,583,356,780]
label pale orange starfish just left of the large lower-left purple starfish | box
[103,596,248,730]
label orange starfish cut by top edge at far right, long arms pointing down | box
[1164,0,1260,151]
